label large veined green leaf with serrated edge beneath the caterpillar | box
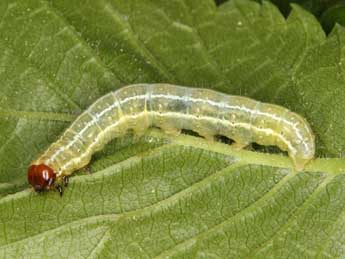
[0,0,345,258]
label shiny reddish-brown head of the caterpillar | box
[28,164,56,192]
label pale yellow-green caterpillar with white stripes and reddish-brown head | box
[28,84,315,194]
